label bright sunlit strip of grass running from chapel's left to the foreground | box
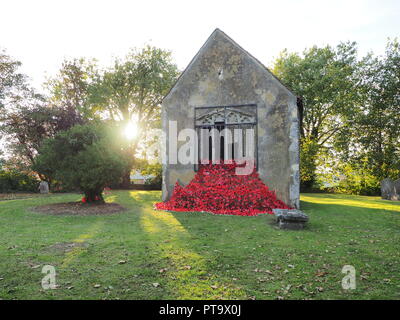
[141,210,246,299]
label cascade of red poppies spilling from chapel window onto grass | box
[155,162,289,216]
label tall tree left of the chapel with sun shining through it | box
[89,46,178,185]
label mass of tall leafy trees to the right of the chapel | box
[273,40,400,192]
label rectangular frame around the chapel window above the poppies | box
[193,103,258,172]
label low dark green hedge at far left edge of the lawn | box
[0,169,39,193]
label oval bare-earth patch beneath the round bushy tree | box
[32,202,126,216]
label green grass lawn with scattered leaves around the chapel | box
[0,191,400,299]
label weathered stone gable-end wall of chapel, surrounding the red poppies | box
[162,29,300,208]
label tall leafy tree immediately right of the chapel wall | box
[273,42,360,188]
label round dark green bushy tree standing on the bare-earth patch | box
[34,124,128,202]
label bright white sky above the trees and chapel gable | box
[0,0,400,89]
